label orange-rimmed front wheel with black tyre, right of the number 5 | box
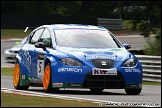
[43,63,59,93]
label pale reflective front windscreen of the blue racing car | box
[54,29,120,48]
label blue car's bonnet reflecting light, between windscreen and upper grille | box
[57,47,131,61]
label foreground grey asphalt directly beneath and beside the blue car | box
[1,76,161,106]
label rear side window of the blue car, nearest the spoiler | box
[30,28,44,44]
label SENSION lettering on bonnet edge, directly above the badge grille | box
[86,56,118,60]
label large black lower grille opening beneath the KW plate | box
[82,72,125,89]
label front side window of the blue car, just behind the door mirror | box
[38,28,52,47]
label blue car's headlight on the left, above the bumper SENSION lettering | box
[60,58,82,66]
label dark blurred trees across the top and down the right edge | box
[1,1,161,55]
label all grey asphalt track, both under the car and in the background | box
[1,36,161,106]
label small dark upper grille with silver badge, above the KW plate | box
[92,59,114,69]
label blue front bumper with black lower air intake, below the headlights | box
[52,62,142,89]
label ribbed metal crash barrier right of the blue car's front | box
[136,55,161,82]
